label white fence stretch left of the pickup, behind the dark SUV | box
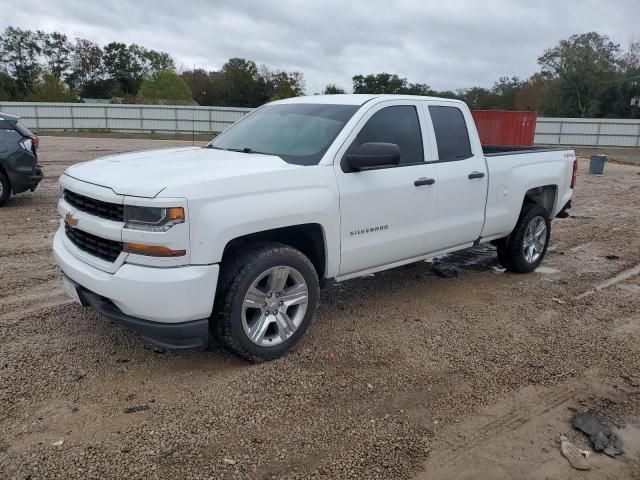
[0,102,251,133]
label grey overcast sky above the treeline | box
[0,0,640,94]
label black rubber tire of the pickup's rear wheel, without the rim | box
[496,203,551,273]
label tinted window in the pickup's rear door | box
[429,105,471,161]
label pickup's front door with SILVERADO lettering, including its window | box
[334,100,437,275]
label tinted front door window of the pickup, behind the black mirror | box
[351,105,424,165]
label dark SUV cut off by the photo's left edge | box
[0,112,42,207]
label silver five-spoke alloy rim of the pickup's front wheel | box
[242,265,309,347]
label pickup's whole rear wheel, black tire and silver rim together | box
[497,204,551,273]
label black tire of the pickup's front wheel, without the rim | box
[211,242,320,362]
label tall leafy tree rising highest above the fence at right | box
[538,32,620,117]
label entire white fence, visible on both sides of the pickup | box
[0,102,640,147]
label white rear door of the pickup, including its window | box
[423,101,489,251]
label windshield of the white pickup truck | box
[208,103,360,165]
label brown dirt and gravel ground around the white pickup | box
[0,137,640,480]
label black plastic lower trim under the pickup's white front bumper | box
[76,284,209,350]
